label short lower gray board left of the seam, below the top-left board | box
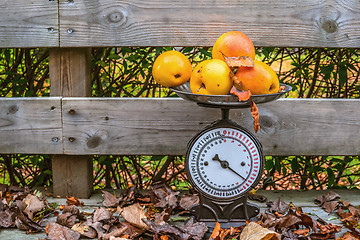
[0,98,63,154]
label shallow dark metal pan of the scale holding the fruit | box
[170,82,292,108]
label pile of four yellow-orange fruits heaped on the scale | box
[152,31,280,100]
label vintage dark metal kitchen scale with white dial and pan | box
[171,83,291,228]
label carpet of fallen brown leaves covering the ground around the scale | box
[0,183,360,240]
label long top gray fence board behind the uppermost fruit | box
[59,0,360,48]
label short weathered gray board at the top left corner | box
[0,0,59,48]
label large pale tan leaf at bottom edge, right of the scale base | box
[240,222,281,240]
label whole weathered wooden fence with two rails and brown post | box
[0,0,360,197]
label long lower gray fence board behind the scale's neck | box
[63,98,360,156]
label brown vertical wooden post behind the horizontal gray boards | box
[49,48,93,198]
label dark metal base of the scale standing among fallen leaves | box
[190,195,260,229]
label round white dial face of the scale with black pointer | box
[187,127,262,199]
